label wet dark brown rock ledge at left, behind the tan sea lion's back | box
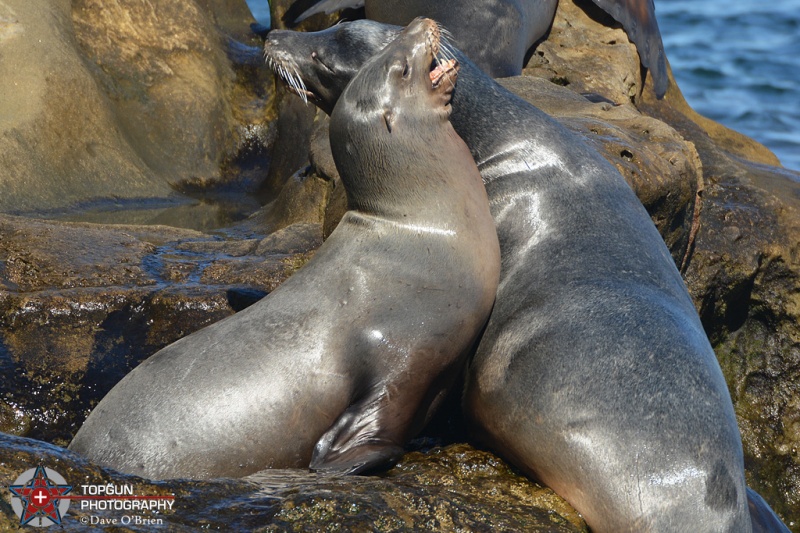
[0,215,322,445]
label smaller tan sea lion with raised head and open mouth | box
[70,21,500,479]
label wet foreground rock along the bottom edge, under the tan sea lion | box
[0,435,588,532]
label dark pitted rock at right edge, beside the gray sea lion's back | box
[686,154,800,527]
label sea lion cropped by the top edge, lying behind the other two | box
[297,0,669,98]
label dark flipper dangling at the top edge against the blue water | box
[592,0,669,98]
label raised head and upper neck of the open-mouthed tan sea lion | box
[330,18,462,211]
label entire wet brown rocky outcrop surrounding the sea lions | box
[0,0,800,531]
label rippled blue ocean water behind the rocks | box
[247,0,800,170]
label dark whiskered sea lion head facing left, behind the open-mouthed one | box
[264,20,402,115]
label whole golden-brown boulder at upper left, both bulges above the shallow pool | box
[0,0,271,213]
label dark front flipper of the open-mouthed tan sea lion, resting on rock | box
[309,394,404,474]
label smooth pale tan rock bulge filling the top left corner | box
[0,0,171,212]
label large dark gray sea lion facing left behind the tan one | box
[265,21,788,532]
